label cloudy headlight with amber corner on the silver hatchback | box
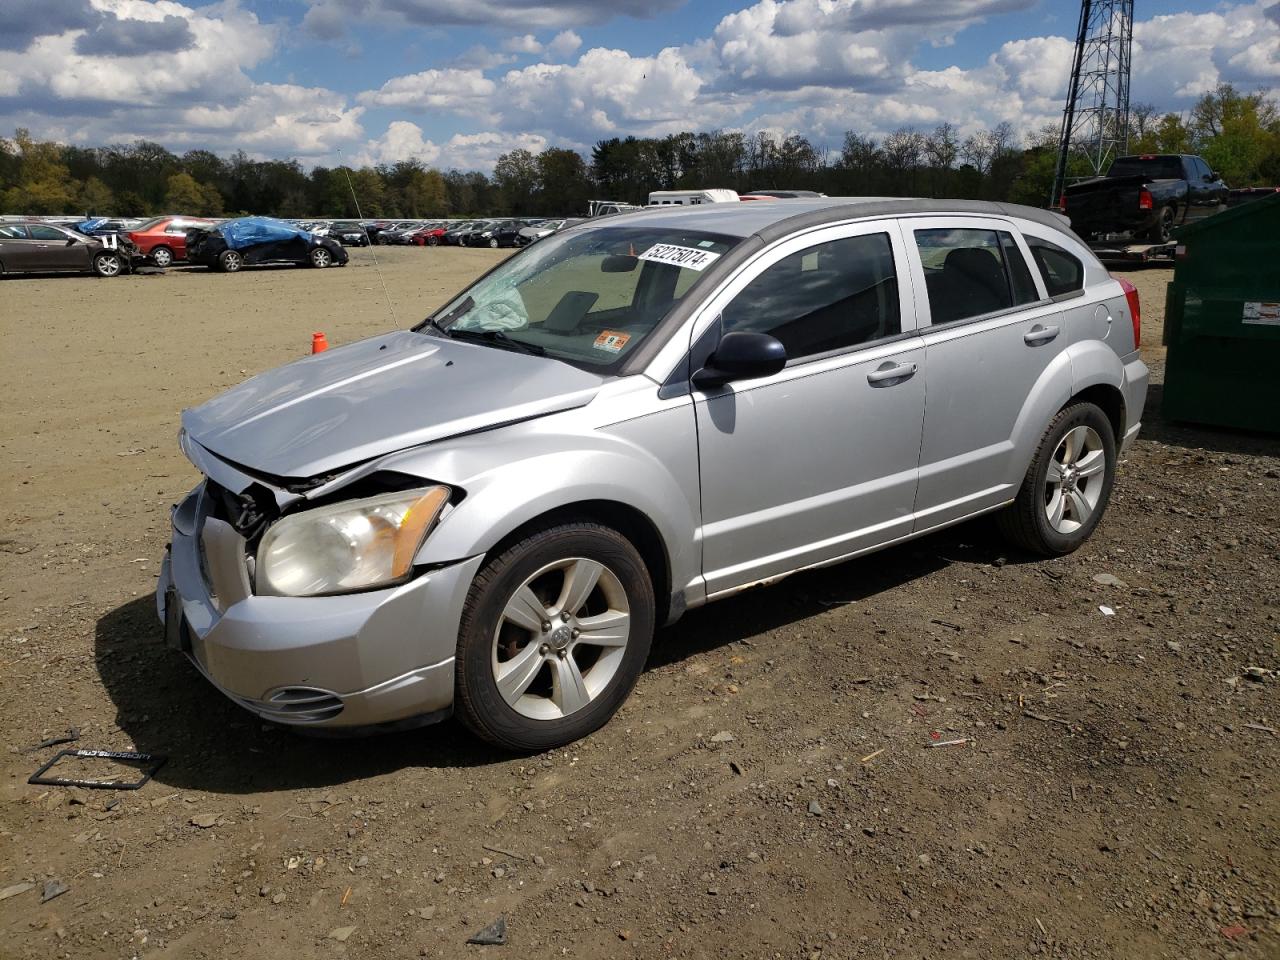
[256,486,449,596]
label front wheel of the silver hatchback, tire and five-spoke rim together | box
[457,524,654,751]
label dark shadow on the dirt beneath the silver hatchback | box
[93,520,1018,794]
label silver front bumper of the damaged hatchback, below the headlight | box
[156,484,483,731]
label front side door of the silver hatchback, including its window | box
[694,221,924,598]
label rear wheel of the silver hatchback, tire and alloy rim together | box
[1000,403,1116,557]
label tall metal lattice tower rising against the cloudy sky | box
[1050,0,1133,206]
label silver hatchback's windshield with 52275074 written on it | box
[422,227,739,369]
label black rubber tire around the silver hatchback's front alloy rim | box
[456,522,655,753]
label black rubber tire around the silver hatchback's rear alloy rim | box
[997,403,1116,557]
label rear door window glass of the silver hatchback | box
[915,228,1039,326]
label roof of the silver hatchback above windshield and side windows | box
[614,197,1069,241]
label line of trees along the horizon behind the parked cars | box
[0,83,1280,219]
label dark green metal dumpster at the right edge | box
[1164,195,1280,433]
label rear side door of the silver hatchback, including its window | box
[902,216,1070,530]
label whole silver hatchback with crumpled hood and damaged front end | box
[156,198,1147,750]
